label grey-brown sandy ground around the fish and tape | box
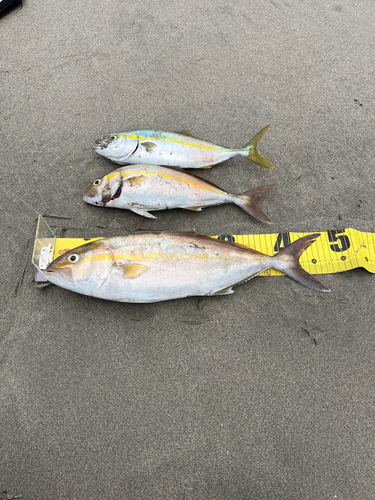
[0,0,375,500]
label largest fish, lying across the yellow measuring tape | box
[45,231,329,302]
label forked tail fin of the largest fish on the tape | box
[272,233,331,292]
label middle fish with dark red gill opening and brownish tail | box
[83,165,273,223]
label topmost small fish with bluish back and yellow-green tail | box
[94,125,273,168]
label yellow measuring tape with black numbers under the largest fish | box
[54,229,375,276]
